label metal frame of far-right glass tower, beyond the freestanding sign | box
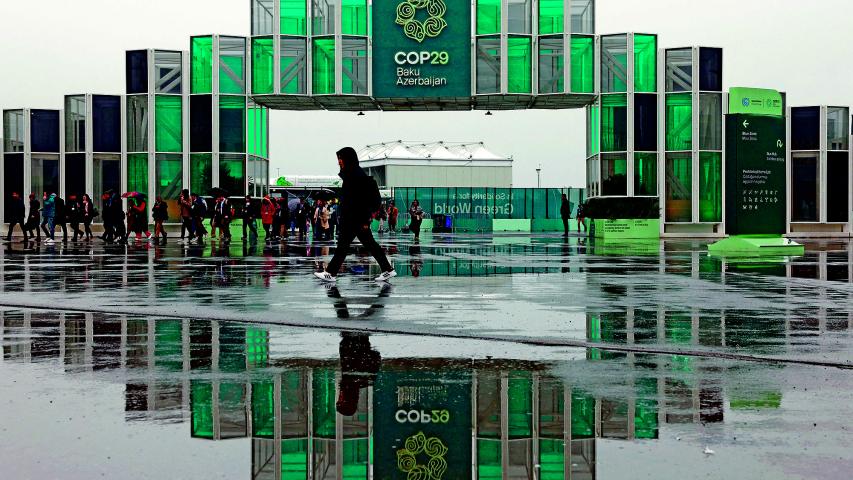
[786,105,853,237]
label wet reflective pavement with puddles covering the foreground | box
[0,235,853,480]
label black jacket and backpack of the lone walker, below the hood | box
[338,163,382,228]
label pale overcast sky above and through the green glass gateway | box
[0,0,853,187]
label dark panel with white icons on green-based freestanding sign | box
[726,114,787,235]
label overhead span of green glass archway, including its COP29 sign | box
[250,0,598,111]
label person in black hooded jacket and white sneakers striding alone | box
[314,147,397,283]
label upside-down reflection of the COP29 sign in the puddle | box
[373,371,472,480]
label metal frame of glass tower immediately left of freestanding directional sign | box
[657,46,728,237]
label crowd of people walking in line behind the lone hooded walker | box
[6,189,424,245]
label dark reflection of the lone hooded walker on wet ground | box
[327,284,392,417]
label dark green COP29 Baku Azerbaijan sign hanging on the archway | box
[373,0,471,98]
